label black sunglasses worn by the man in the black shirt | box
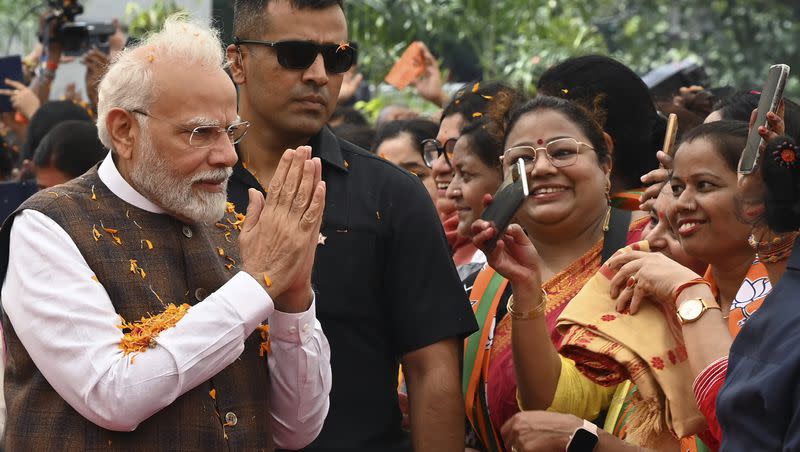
[233,37,358,74]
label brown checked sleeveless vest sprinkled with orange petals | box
[0,167,273,451]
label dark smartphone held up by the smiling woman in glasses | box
[481,159,530,254]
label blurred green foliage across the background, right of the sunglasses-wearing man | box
[346,0,800,96]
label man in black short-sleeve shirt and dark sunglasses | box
[227,0,477,451]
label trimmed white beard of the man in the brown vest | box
[131,130,228,223]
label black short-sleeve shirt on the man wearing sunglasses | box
[228,127,477,451]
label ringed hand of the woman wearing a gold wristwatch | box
[604,247,700,314]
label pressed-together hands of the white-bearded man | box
[239,146,325,312]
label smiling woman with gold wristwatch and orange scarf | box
[580,121,772,450]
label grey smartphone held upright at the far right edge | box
[739,64,789,174]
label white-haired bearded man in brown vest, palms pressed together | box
[0,17,331,450]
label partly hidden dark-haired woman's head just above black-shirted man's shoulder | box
[372,119,439,199]
